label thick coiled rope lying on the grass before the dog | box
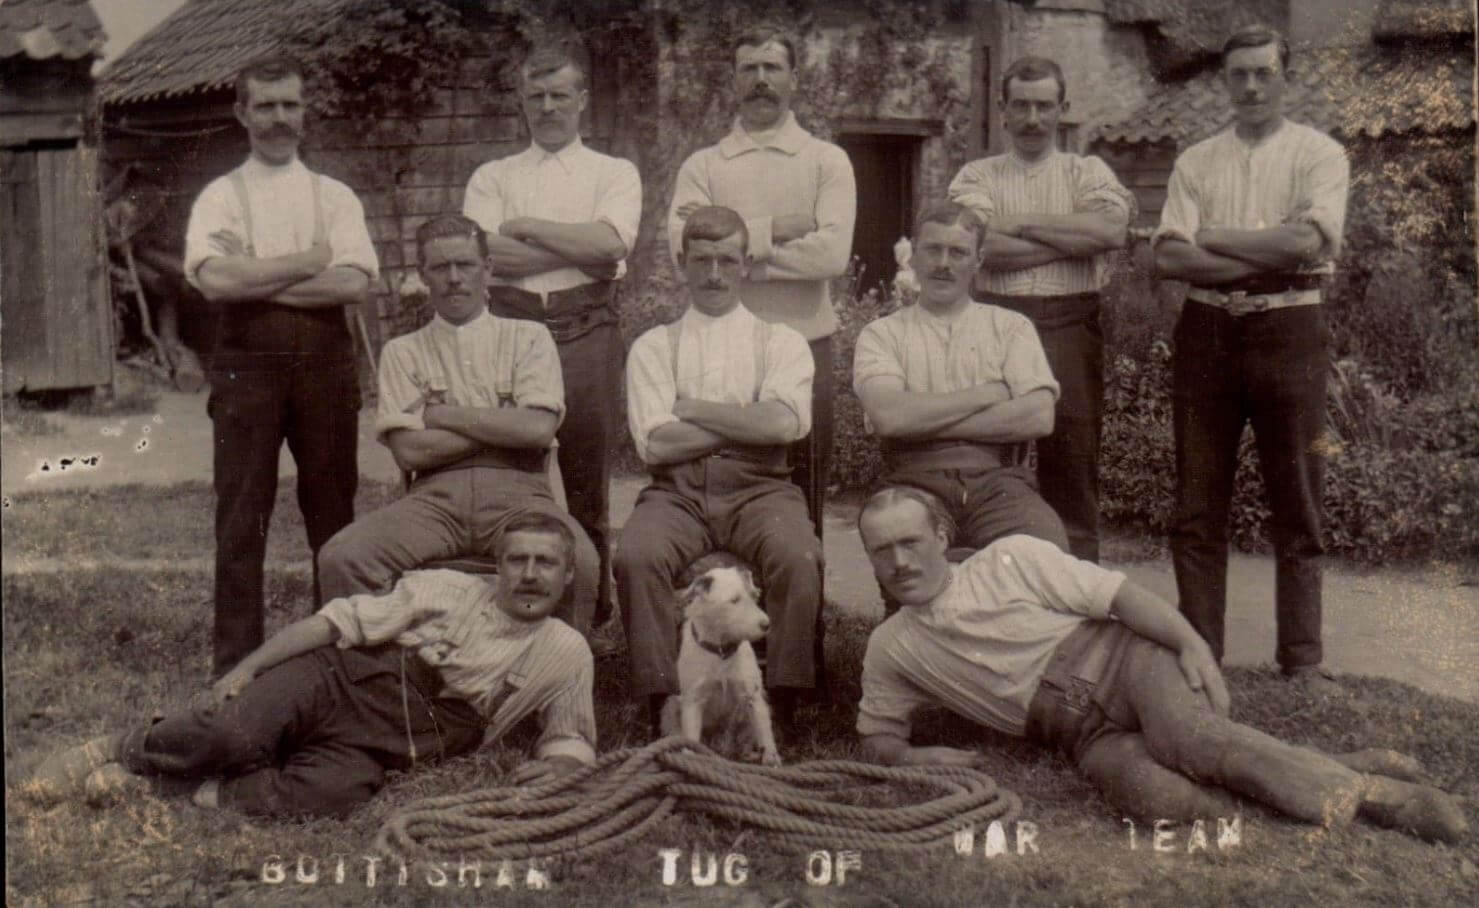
[376,736,1022,861]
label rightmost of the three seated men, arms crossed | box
[852,203,1068,573]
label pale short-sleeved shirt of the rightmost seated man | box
[852,303,1057,399]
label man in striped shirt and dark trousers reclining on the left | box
[27,513,596,815]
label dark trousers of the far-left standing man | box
[206,353,359,674]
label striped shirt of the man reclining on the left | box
[318,571,596,763]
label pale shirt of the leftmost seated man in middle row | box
[374,311,565,442]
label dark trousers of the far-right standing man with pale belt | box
[1171,300,1330,668]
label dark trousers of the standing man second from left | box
[490,294,626,615]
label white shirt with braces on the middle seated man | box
[627,305,816,463]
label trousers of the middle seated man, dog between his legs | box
[614,457,822,699]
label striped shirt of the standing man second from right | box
[950,151,1134,296]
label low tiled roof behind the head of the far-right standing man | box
[1093,44,1475,148]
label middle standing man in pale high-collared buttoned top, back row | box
[667,28,858,534]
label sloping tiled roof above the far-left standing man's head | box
[98,0,346,104]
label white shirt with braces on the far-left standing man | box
[185,157,380,290]
